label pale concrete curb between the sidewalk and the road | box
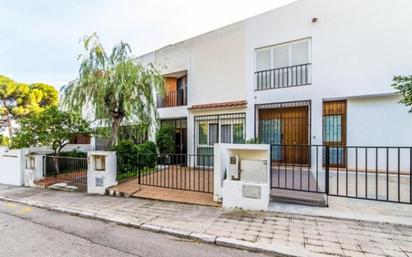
[0,196,313,257]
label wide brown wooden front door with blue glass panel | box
[259,106,310,165]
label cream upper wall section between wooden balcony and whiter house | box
[144,22,246,118]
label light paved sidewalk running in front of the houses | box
[0,185,412,256]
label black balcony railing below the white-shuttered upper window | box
[255,63,312,91]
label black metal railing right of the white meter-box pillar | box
[271,145,412,204]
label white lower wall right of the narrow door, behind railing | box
[347,96,412,173]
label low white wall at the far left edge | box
[0,147,28,186]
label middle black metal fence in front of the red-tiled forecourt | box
[117,154,213,193]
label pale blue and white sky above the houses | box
[0,0,294,88]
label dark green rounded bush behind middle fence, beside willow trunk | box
[113,140,157,175]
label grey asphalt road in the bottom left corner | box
[0,201,267,257]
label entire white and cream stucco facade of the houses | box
[142,0,412,152]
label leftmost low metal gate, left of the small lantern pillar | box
[44,155,87,184]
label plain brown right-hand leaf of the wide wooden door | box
[281,106,309,164]
